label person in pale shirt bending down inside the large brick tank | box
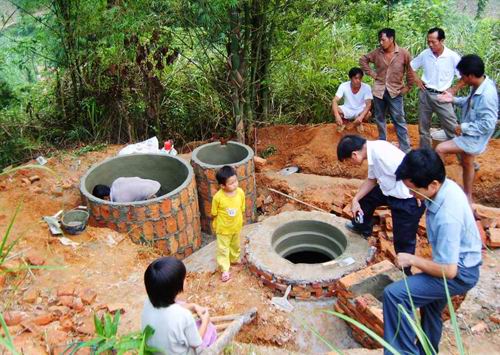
[92,177,161,202]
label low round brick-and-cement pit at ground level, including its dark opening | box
[245,211,368,300]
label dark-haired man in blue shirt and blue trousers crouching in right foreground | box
[384,149,481,354]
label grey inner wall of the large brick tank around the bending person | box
[84,154,189,202]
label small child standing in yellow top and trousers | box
[211,165,245,282]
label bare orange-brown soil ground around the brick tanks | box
[0,125,500,354]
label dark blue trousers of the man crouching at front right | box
[384,265,479,354]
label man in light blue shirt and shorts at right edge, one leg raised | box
[436,54,498,209]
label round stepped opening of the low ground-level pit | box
[271,220,347,264]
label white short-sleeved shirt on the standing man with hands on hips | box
[410,47,461,91]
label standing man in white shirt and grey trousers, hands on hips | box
[410,27,463,148]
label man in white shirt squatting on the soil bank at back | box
[332,68,373,132]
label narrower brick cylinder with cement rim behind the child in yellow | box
[191,141,256,233]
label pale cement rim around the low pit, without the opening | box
[245,211,368,297]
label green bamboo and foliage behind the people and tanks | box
[0,0,500,166]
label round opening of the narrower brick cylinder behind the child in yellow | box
[196,142,249,165]
